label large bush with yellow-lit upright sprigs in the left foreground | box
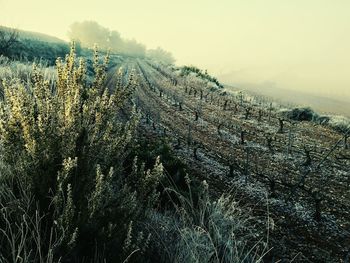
[0,47,162,262]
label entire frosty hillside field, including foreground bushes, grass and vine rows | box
[0,36,350,262]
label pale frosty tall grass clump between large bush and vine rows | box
[149,182,268,263]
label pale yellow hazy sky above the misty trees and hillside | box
[0,0,350,100]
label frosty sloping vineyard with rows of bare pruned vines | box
[120,60,350,262]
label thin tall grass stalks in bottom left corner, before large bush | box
[0,180,58,263]
